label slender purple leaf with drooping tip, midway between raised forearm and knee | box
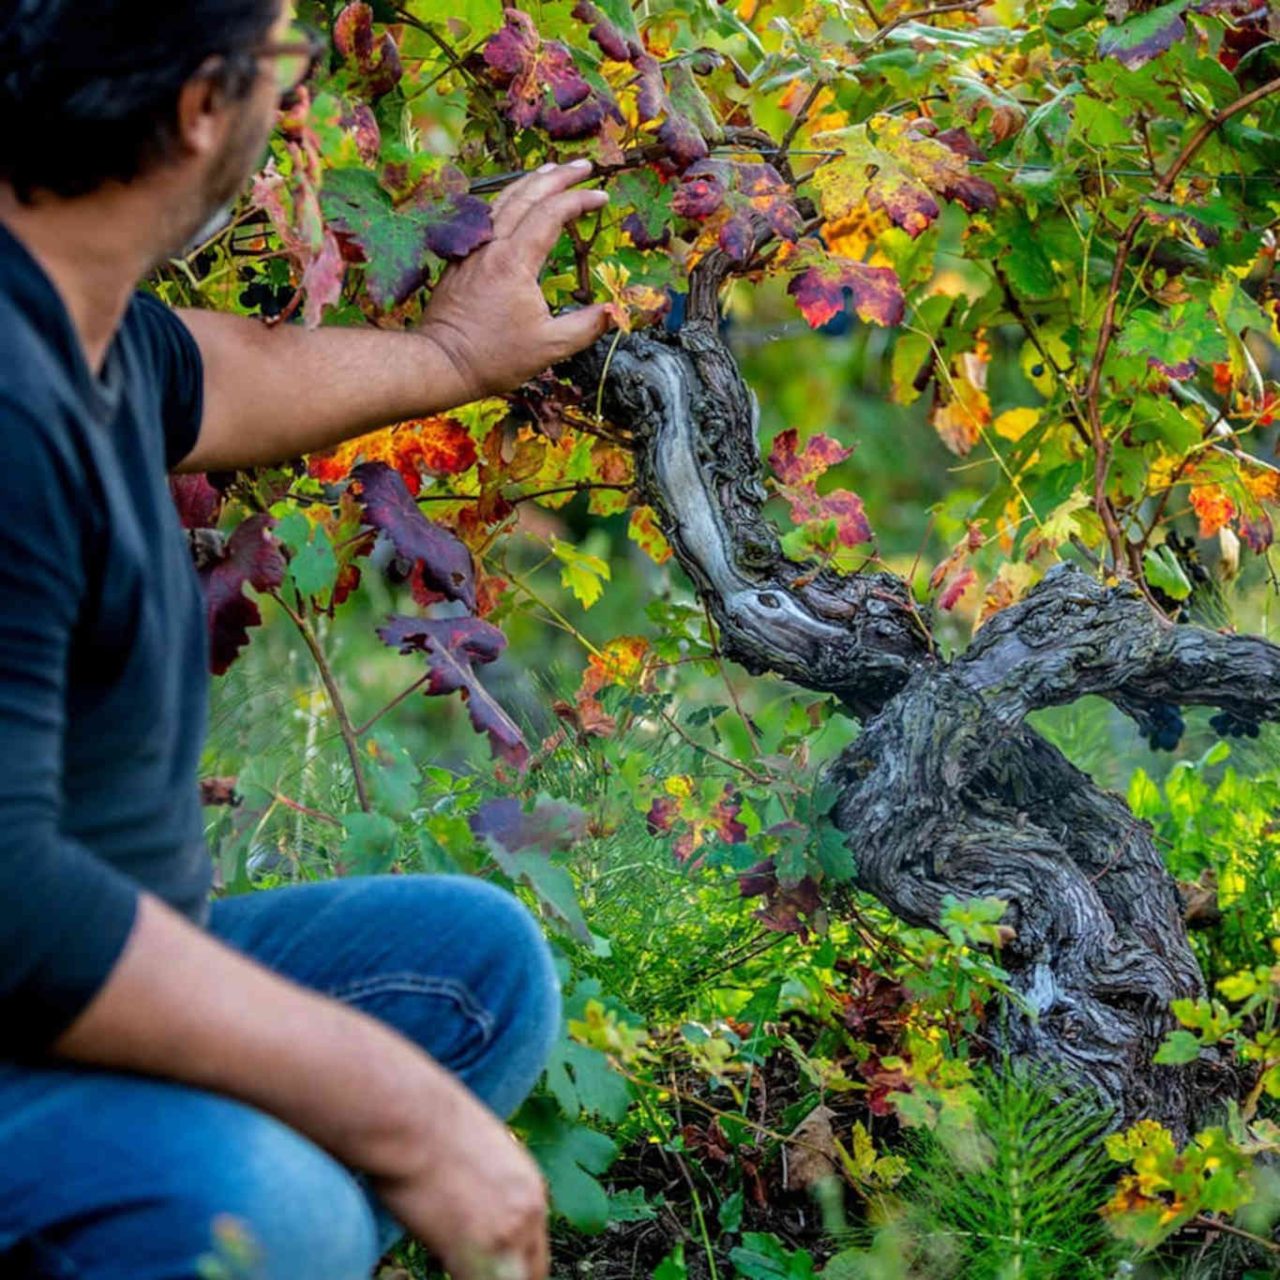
[378,617,529,769]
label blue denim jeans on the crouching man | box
[0,876,559,1280]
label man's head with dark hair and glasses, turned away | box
[0,0,297,248]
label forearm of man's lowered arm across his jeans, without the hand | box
[54,896,475,1179]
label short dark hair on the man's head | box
[0,0,279,201]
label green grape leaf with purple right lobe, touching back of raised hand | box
[320,168,493,307]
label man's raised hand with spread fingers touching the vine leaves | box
[421,160,609,399]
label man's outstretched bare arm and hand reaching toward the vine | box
[180,164,608,471]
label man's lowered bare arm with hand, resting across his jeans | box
[54,895,547,1280]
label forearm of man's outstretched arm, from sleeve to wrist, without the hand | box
[172,311,468,471]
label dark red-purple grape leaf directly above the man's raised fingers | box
[484,9,617,140]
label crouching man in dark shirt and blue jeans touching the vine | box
[0,0,607,1280]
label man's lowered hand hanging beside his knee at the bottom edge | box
[374,1084,549,1280]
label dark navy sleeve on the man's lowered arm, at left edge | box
[0,399,140,1056]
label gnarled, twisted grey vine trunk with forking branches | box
[570,264,1280,1137]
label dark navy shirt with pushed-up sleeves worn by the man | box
[0,227,210,1056]
